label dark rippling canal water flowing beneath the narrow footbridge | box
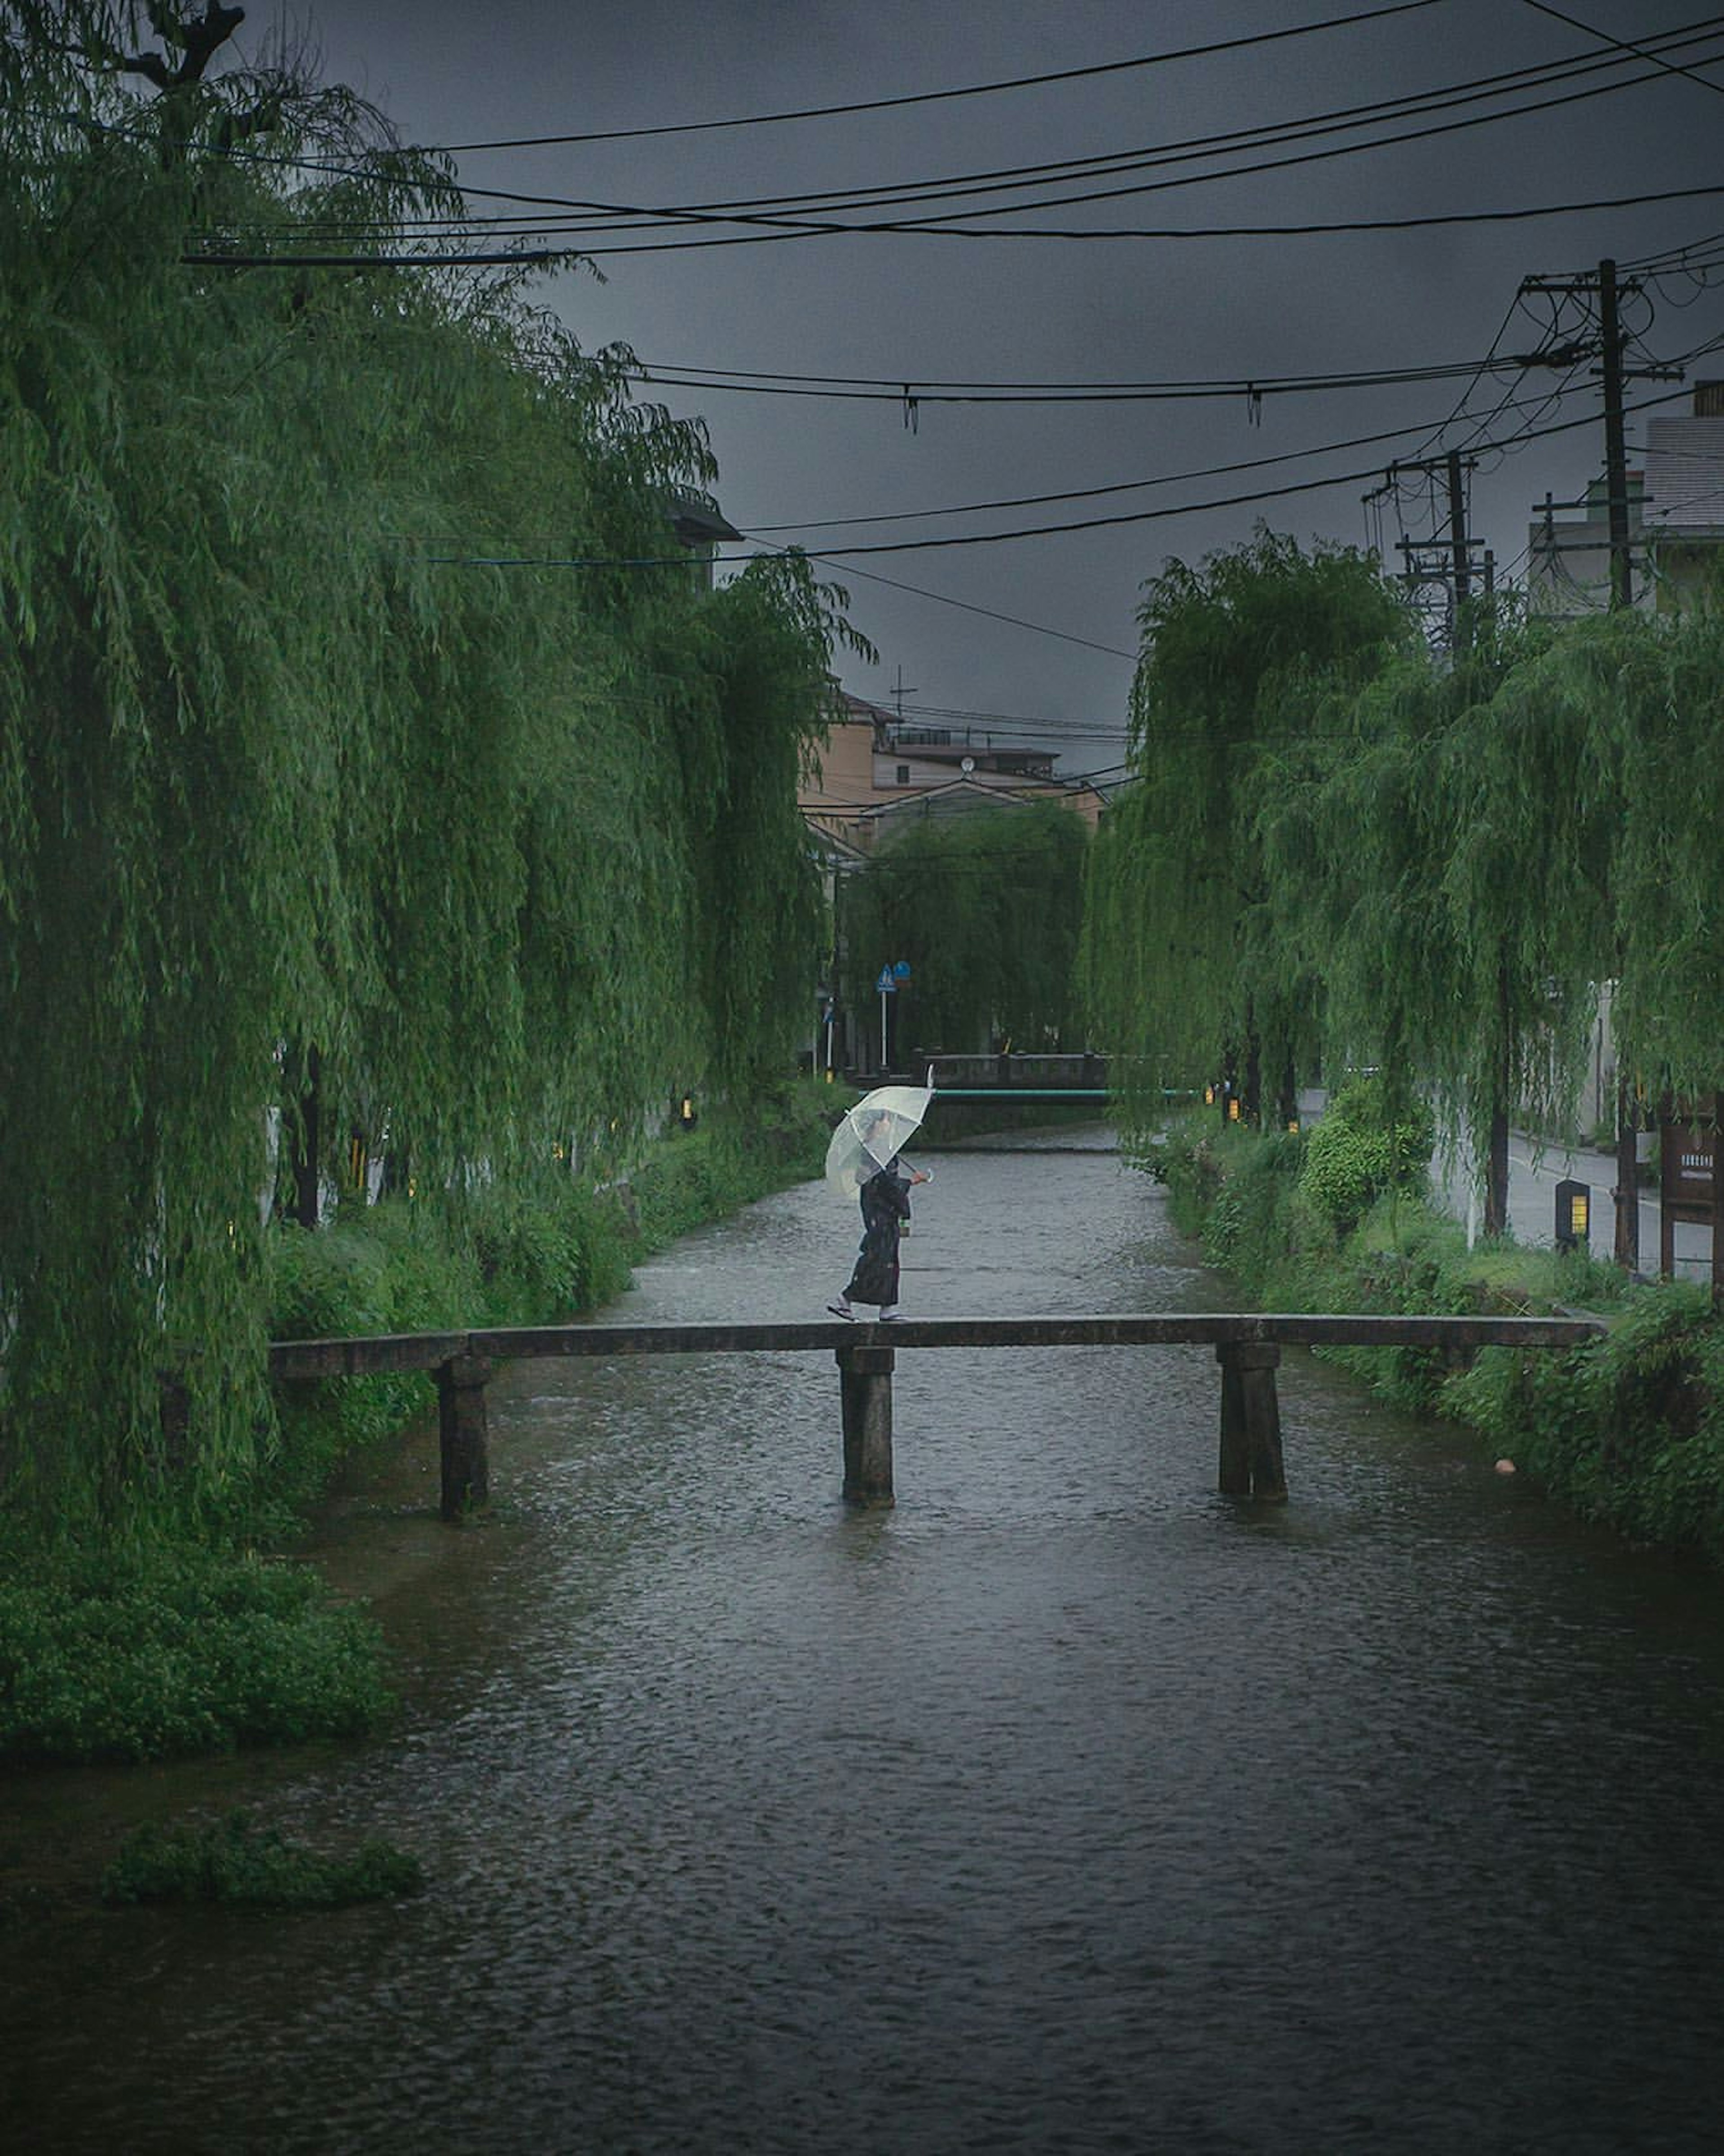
[0,1145,1724,2156]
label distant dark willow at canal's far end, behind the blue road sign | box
[838,802,1088,1052]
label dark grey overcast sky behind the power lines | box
[256,0,1724,774]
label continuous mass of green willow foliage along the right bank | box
[1086,504,1724,1218]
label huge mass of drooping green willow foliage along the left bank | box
[0,21,845,1518]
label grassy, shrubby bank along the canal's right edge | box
[1140,1093,1724,1563]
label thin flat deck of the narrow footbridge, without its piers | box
[269,1311,1608,1377]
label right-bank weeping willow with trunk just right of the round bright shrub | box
[1258,632,1621,1231]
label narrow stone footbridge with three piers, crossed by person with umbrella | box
[269,1311,1608,1520]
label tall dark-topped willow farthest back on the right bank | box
[1084,530,1409,1113]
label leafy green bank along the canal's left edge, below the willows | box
[0,1084,849,1761]
